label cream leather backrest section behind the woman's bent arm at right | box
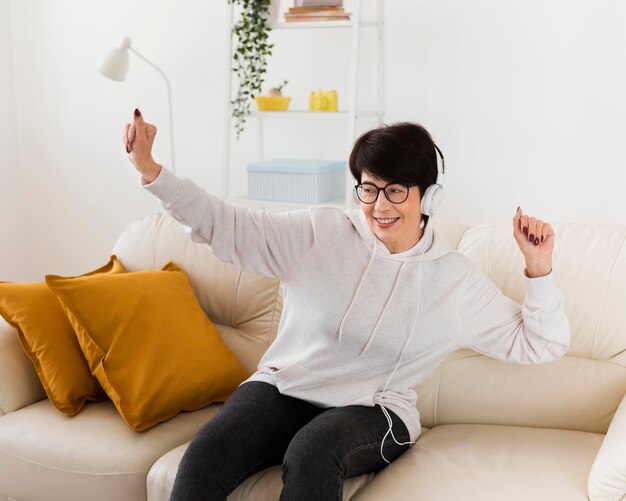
[416,219,626,433]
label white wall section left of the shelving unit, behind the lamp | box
[0,0,226,280]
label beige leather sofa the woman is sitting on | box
[0,213,626,501]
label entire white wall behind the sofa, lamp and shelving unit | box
[0,0,626,280]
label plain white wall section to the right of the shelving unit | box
[380,0,626,224]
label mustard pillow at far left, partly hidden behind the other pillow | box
[0,256,125,416]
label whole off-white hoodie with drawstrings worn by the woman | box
[144,168,570,441]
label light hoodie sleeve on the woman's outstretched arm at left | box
[142,168,313,280]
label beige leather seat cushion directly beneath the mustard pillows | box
[0,399,220,501]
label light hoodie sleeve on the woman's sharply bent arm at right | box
[459,267,570,364]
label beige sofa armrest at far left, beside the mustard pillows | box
[0,317,46,415]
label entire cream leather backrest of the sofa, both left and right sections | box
[113,213,626,433]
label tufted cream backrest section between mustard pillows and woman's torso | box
[113,212,282,373]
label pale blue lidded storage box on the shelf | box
[247,159,347,204]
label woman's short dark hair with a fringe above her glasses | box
[350,122,437,196]
